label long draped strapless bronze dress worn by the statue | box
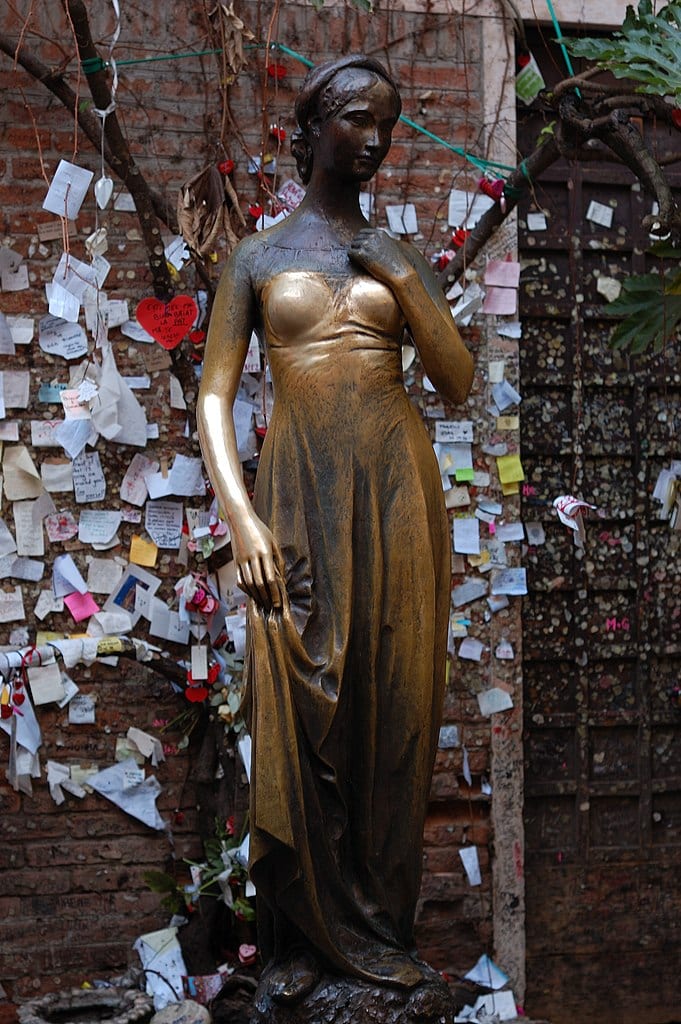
[247,269,451,988]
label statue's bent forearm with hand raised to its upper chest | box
[349,228,474,404]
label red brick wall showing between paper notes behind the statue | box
[0,2,499,999]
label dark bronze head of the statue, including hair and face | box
[291,54,401,184]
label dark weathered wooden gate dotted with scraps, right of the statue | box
[520,24,681,1024]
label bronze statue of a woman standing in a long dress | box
[199,56,473,1022]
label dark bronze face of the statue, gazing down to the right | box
[310,70,397,181]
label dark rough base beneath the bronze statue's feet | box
[246,975,455,1024]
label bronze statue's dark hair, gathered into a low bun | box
[291,53,402,184]
